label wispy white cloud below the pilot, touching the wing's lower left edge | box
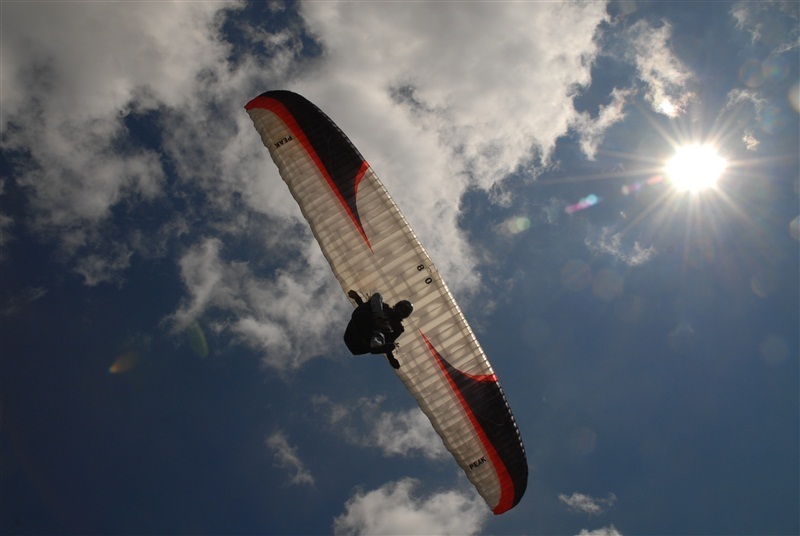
[312,395,448,460]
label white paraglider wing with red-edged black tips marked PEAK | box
[245,91,528,514]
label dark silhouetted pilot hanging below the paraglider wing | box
[344,290,414,369]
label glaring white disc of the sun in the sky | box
[665,145,728,192]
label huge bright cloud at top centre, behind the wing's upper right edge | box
[297,2,606,288]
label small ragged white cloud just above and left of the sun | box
[625,20,694,117]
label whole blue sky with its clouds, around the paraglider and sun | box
[0,1,800,535]
